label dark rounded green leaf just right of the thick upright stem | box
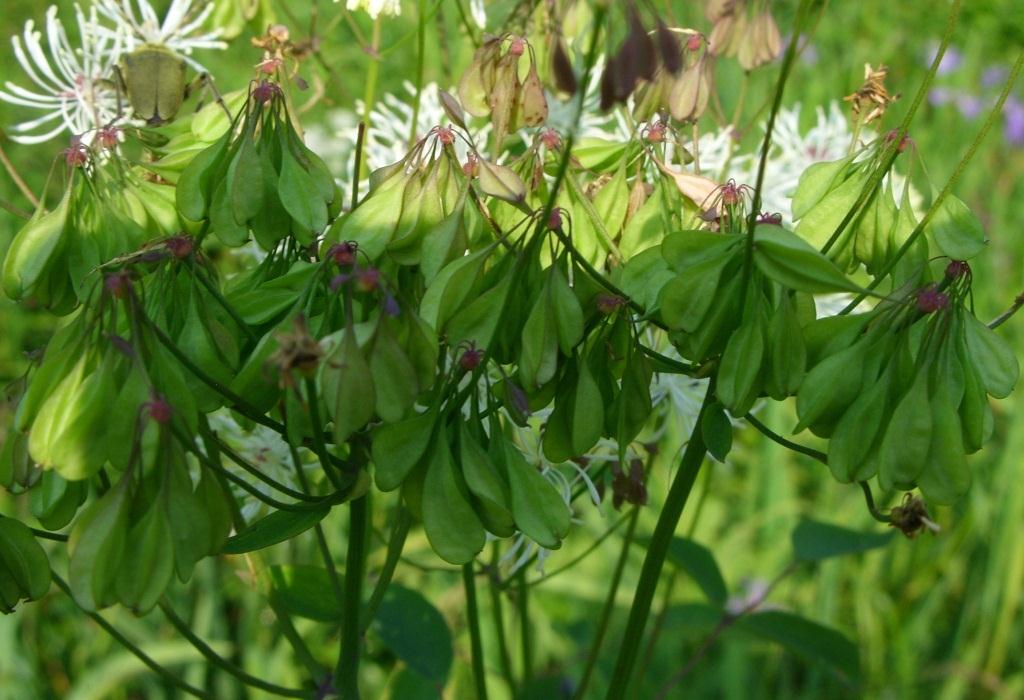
[374,583,455,686]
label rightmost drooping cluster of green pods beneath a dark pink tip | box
[797,262,1019,504]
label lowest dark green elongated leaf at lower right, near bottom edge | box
[736,610,860,682]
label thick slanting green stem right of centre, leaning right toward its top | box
[607,381,715,699]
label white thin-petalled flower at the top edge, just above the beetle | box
[95,0,227,73]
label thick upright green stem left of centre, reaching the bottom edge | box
[334,495,368,700]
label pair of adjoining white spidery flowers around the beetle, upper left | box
[0,0,226,143]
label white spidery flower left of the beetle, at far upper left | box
[0,5,122,143]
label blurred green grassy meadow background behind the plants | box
[0,0,1024,700]
